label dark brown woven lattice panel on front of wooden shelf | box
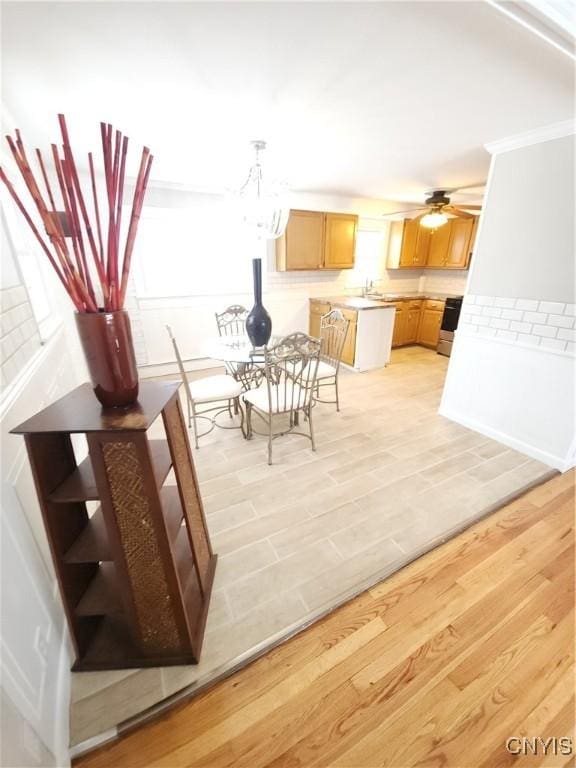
[102,442,181,652]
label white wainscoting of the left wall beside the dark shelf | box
[0,328,77,766]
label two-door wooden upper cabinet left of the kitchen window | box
[276,211,358,272]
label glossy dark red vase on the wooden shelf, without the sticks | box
[76,310,138,408]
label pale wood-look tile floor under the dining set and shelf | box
[71,347,552,744]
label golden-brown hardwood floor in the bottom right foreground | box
[76,472,574,768]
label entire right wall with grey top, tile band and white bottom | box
[440,127,576,470]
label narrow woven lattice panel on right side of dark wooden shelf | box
[164,401,212,591]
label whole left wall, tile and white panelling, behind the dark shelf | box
[0,176,85,768]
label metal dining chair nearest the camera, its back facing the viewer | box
[243,333,321,464]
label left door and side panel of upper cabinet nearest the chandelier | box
[276,211,324,271]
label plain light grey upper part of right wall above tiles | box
[468,136,576,303]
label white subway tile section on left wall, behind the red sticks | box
[0,285,41,387]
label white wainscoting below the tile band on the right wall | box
[440,326,576,472]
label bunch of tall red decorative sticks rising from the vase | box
[0,115,152,312]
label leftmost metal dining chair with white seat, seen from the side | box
[166,325,245,448]
